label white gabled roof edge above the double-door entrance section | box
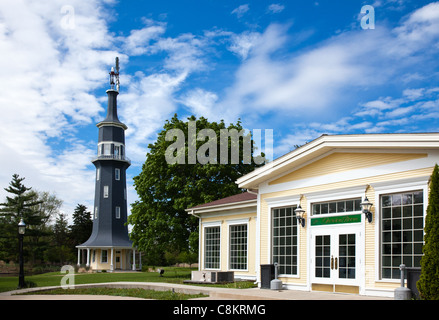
[236,133,439,189]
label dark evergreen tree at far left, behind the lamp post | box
[0,174,44,261]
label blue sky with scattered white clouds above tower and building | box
[0,0,439,221]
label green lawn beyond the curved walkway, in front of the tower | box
[0,267,196,292]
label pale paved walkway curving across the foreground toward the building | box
[0,282,393,300]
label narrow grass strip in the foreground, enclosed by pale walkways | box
[17,288,207,300]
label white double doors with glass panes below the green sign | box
[310,227,362,286]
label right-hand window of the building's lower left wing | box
[229,224,247,270]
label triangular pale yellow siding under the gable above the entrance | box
[269,153,427,185]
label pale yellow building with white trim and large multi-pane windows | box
[188,133,439,297]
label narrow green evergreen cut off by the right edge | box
[417,164,439,300]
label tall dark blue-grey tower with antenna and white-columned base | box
[77,58,141,271]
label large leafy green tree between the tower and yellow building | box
[128,115,264,263]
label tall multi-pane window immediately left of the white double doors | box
[272,206,298,275]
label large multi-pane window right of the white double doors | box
[381,191,424,279]
